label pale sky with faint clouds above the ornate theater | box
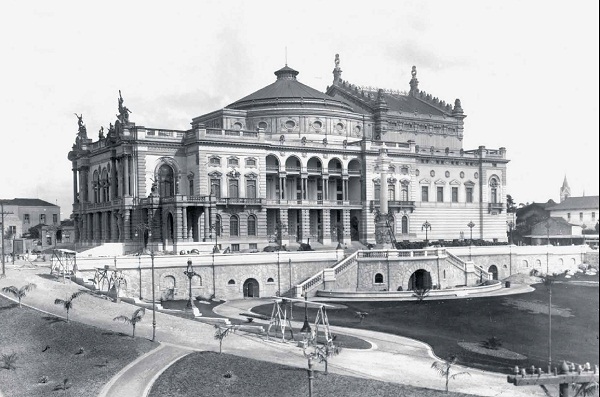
[0,0,599,219]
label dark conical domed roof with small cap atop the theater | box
[227,65,352,111]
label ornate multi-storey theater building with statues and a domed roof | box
[69,56,508,252]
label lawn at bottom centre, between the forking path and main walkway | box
[149,352,478,397]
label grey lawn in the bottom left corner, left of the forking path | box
[0,297,158,397]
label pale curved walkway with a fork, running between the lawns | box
[0,266,544,397]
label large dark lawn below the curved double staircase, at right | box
[253,276,599,373]
